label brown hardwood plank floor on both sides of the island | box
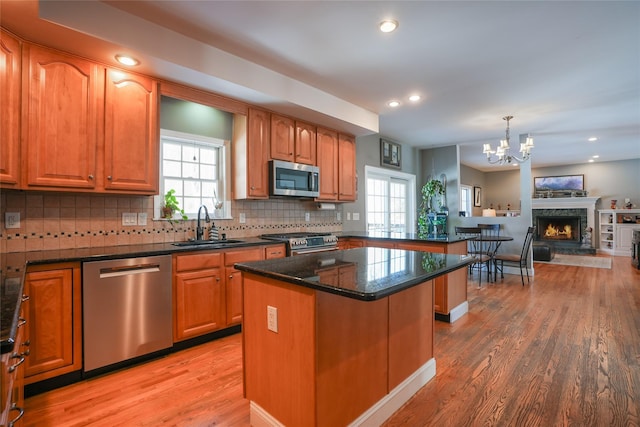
[24,257,640,427]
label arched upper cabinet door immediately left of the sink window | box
[104,70,159,194]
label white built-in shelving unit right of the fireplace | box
[594,209,640,256]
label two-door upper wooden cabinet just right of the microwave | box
[317,128,357,202]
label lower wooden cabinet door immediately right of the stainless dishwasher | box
[174,268,226,341]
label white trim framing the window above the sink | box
[153,129,233,221]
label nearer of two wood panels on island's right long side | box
[316,292,388,426]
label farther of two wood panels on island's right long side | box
[388,280,434,392]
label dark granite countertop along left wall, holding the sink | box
[0,237,278,353]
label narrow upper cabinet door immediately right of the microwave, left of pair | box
[316,128,339,201]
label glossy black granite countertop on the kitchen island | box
[235,247,472,301]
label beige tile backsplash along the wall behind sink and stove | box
[0,190,342,252]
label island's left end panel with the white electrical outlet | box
[242,272,316,426]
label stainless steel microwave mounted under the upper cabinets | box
[269,160,320,197]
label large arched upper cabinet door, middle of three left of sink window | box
[23,45,104,189]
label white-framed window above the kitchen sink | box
[156,129,231,218]
